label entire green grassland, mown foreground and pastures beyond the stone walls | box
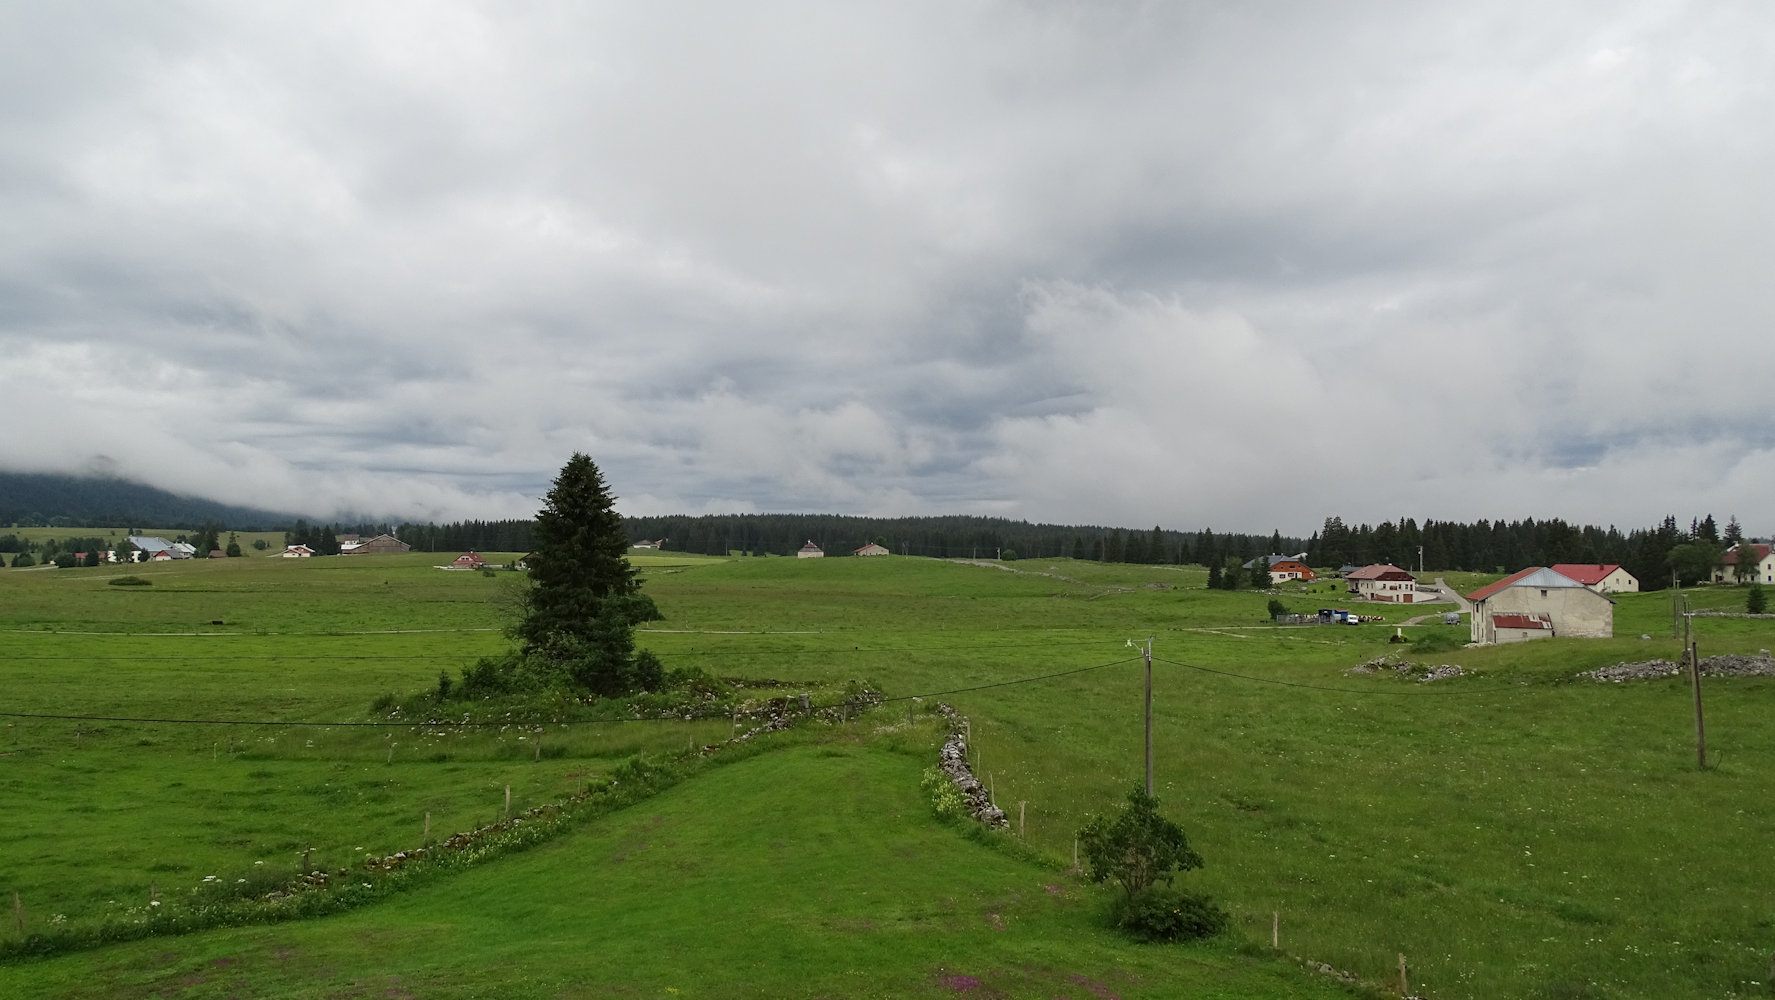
[0,552,1775,1000]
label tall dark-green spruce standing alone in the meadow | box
[517,451,660,696]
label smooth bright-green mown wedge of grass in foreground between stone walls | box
[0,744,1345,1000]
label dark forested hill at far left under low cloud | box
[0,471,295,531]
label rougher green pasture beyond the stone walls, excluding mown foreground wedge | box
[0,556,1775,996]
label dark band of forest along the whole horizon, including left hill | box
[0,472,1743,590]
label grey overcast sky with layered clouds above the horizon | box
[0,0,1775,535]
